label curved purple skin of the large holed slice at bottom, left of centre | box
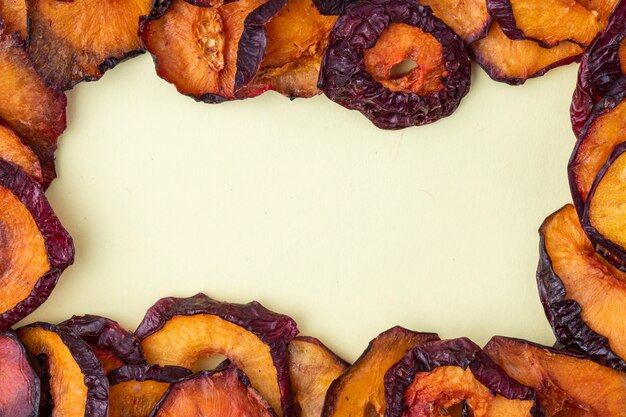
[135,293,298,417]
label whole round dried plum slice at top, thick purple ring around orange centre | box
[318,0,470,129]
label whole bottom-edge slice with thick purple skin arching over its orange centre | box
[385,338,543,417]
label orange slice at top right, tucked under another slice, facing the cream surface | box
[471,21,583,85]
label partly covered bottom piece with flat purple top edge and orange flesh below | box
[107,365,192,417]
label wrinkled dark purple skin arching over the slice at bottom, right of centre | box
[385,338,544,417]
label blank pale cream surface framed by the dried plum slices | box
[19,56,576,360]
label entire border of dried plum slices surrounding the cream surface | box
[0,0,626,417]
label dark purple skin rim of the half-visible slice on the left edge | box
[0,159,74,331]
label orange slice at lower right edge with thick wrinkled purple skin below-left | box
[537,205,626,369]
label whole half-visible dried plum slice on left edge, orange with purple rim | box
[0,159,74,331]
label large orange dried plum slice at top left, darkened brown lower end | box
[27,0,152,90]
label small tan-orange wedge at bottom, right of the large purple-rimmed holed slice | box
[287,337,350,417]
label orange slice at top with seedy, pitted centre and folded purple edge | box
[139,0,286,103]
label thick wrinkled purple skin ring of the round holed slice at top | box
[318,0,471,129]
